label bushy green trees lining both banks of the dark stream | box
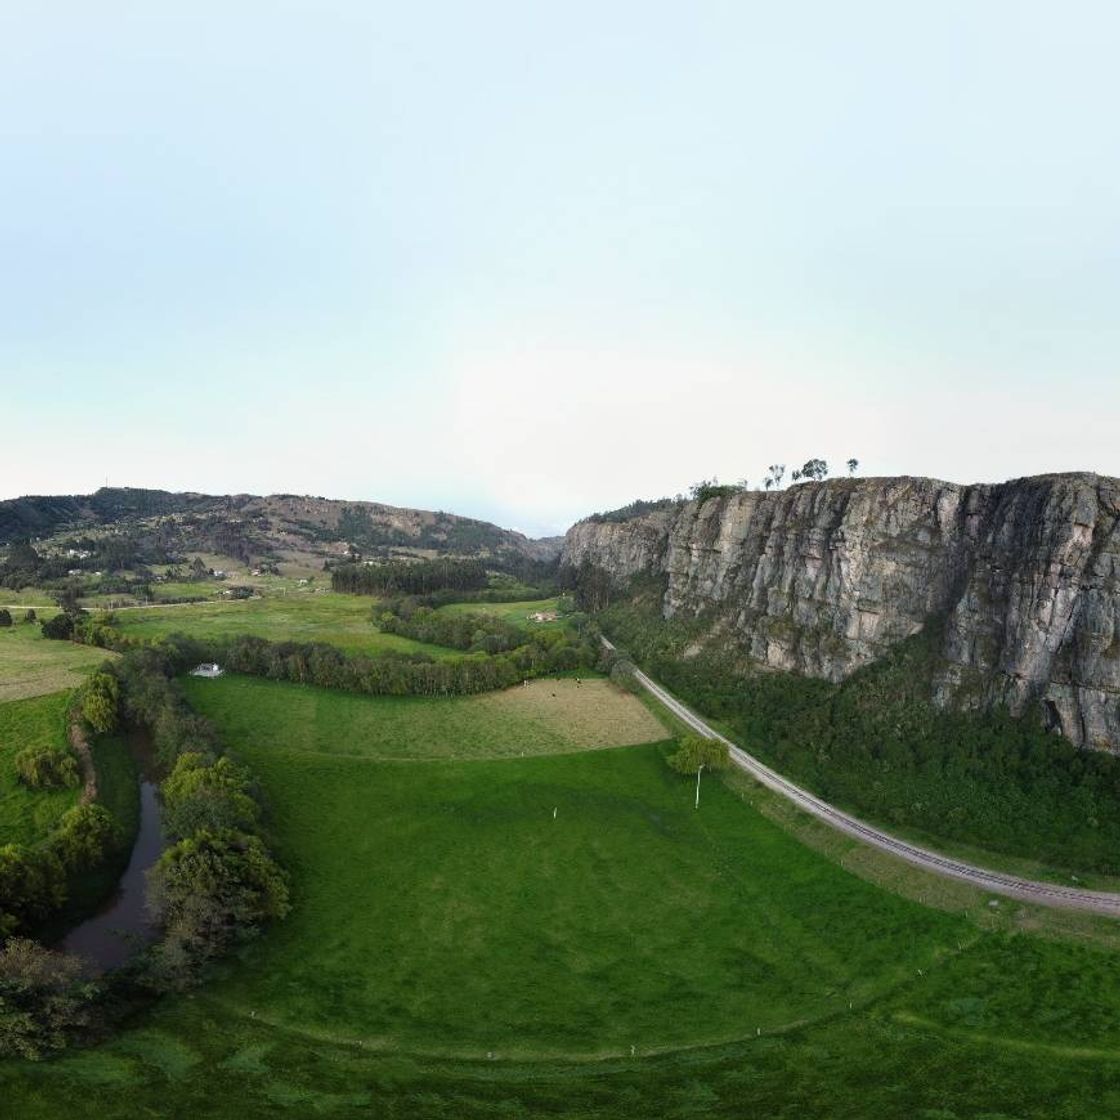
[0,643,290,1058]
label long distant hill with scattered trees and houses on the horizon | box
[0,487,563,561]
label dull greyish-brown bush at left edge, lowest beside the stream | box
[0,937,97,1061]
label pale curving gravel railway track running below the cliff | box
[603,638,1120,916]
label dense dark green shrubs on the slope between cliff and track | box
[599,588,1120,874]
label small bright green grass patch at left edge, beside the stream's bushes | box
[0,694,81,846]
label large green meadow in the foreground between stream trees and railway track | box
[10,678,1120,1120]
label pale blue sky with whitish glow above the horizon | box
[0,0,1120,535]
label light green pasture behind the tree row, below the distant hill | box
[104,590,458,657]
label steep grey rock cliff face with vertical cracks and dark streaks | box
[562,475,1120,750]
